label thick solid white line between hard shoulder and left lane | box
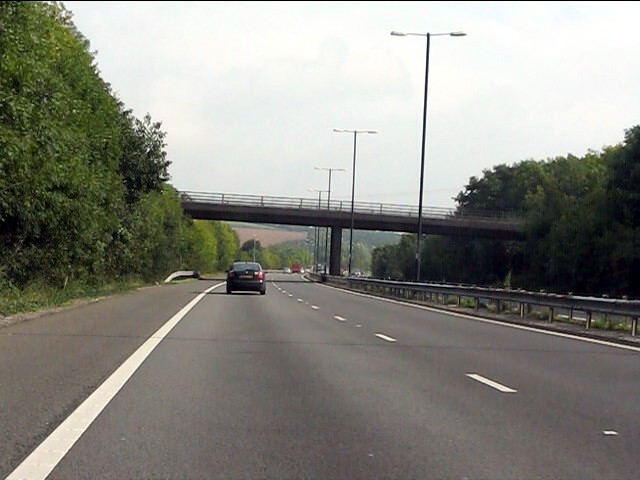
[6,282,225,480]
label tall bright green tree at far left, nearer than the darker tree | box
[0,2,122,285]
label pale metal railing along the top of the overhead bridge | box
[180,191,520,223]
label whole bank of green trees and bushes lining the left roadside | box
[0,2,238,314]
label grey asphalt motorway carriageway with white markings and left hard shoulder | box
[0,274,640,480]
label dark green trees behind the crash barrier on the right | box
[373,126,640,297]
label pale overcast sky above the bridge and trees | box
[64,1,640,207]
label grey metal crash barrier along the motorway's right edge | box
[316,275,640,336]
